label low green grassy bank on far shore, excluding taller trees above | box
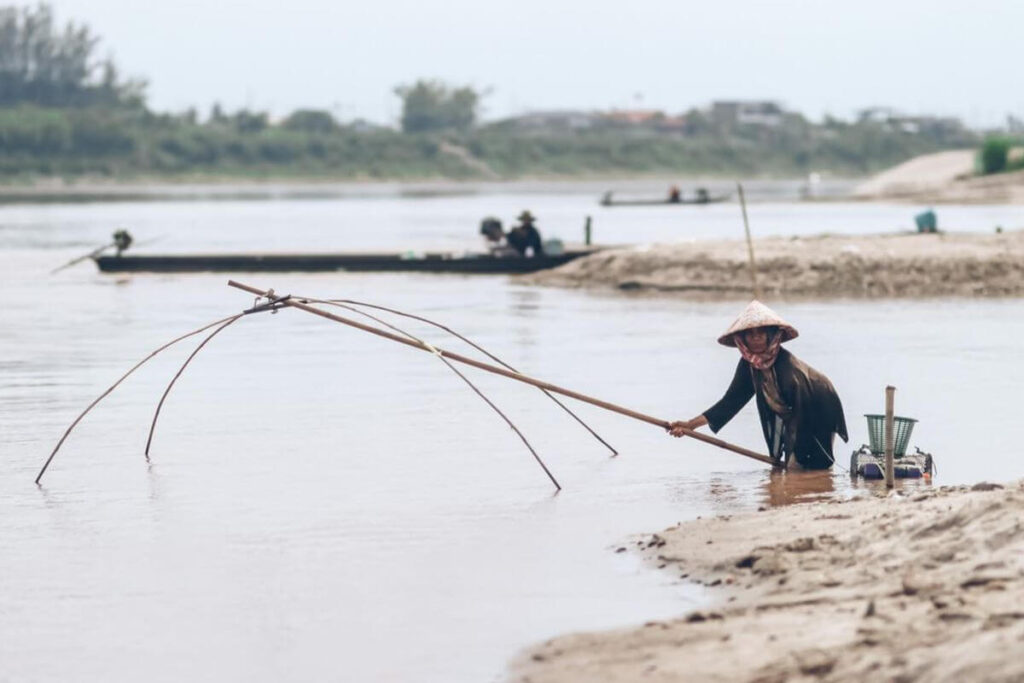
[0,104,976,183]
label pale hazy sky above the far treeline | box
[46,0,1024,126]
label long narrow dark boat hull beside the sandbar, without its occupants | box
[93,248,597,274]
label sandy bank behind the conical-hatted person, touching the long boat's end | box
[524,230,1024,298]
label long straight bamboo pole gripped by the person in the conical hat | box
[227,280,778,466]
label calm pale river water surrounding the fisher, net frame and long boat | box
[0,187,1024,681]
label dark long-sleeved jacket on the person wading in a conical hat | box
[703,348,848,469]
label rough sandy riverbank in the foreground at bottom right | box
[511,483,1024,683]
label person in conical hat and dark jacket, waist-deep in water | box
[669,301,848,469]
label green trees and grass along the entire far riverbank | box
[0,5,978,182]
